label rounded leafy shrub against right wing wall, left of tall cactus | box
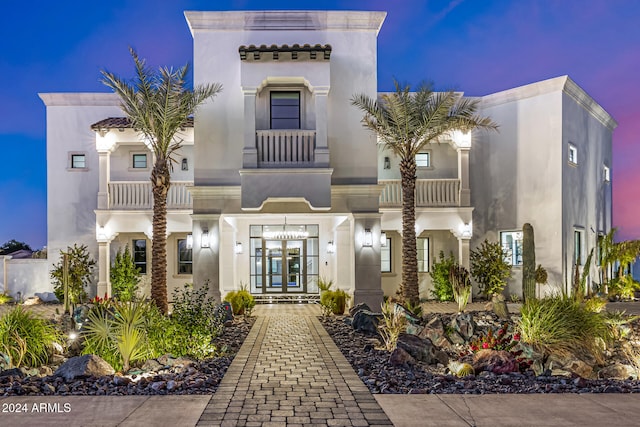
[470,240,511,296]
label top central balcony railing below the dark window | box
[256,130,316,168]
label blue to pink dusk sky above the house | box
[0,0,640,249]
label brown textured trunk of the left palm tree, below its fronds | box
[151,159,171,314]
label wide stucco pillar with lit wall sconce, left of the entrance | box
[192,214,220,301]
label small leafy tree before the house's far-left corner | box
[51,243,96,304]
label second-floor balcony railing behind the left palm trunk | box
[109,181,193,210]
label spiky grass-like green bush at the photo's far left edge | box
[0,306,62,368]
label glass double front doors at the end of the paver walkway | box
[261,240,307,293]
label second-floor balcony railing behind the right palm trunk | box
[378,179,460,207]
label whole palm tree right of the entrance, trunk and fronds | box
[351,82,498,304]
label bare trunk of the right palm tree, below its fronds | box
[400,157,420,304]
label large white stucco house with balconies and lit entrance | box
[40,11,616,306]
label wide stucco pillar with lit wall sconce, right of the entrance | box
[351,213,384,311]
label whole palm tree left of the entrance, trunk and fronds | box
[101,48,222,313]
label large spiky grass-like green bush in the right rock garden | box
[518,295,611,362]
